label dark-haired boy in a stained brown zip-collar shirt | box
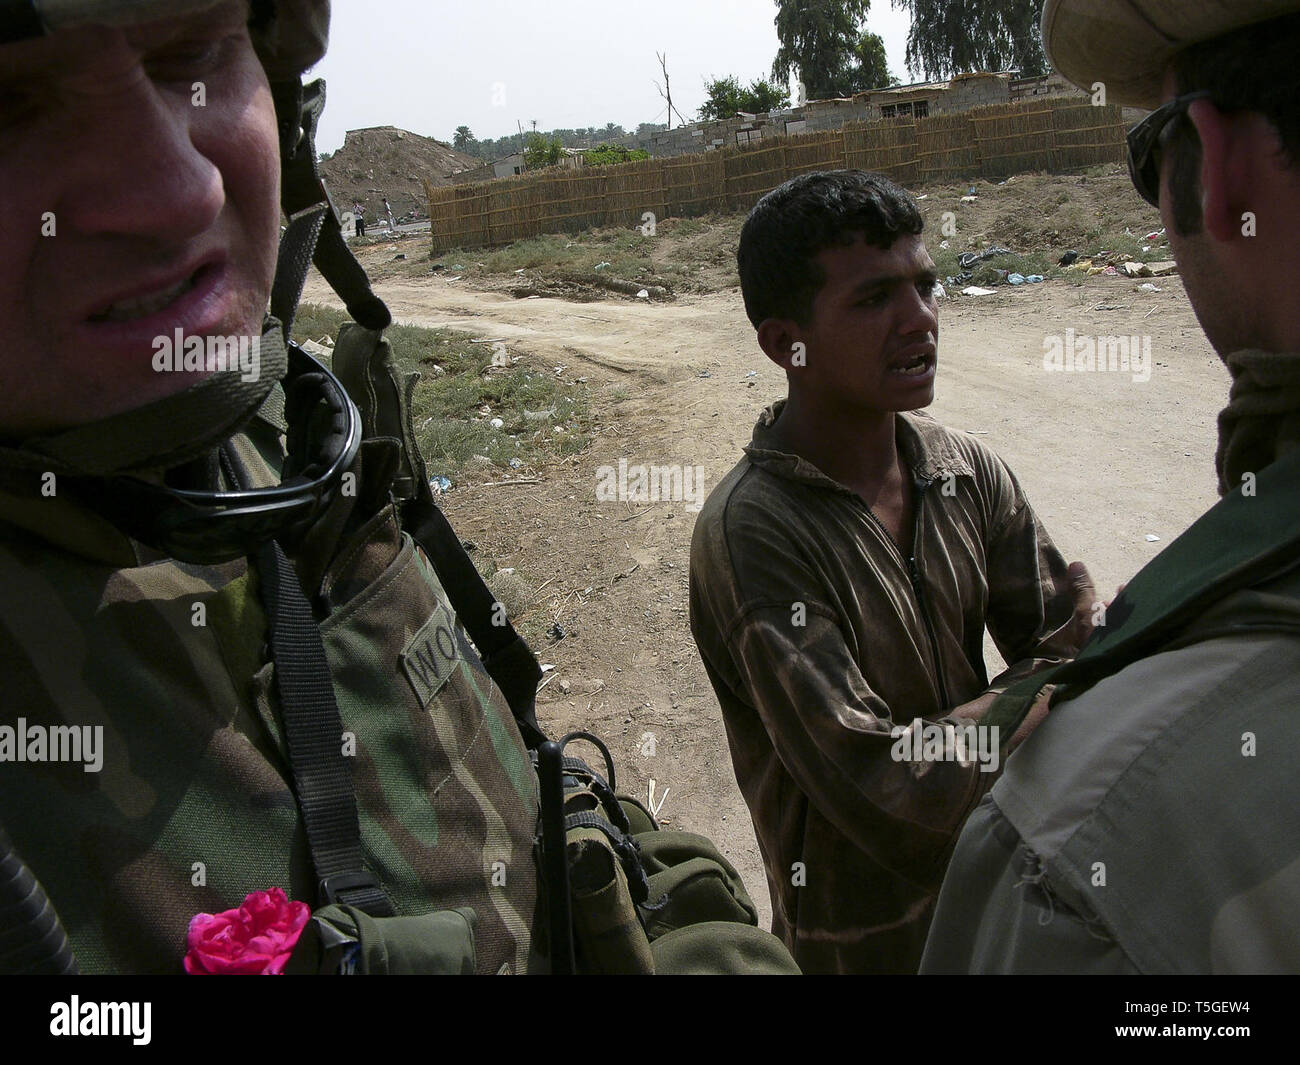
[690,170,1093,973]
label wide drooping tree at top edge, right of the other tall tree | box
[893,0,1047,78]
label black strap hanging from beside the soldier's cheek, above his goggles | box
[273,81,393,330]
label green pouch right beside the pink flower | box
[285,904,478,977]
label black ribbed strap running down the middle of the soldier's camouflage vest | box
[257,540,394,917]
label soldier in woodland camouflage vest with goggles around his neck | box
[0,0,537,973]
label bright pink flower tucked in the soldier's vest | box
[185,888,312,977]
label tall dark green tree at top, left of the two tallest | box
[772,0,892,100]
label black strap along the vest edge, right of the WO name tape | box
[403,494,546,749]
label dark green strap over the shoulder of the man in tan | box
[980,450,1300,746]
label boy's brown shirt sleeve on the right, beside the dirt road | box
[976,453,1079,692]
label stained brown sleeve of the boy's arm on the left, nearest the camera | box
[728,603,992,891]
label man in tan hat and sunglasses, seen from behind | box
[922,0,1300,973]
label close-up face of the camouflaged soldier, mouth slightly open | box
[0,0,280,440]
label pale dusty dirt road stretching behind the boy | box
[306,227,1227,921]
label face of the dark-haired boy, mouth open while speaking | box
[790,234,939,414]
